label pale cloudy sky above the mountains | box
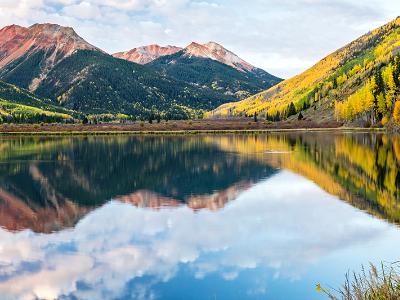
[0,0,400,78]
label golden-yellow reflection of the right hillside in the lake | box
[209,132,400,223]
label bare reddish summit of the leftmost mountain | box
[0,23,101,90]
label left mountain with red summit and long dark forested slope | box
[0,24,238,118]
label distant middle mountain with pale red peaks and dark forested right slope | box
[113,42,281,101]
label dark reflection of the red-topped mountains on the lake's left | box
[0,137,274,232]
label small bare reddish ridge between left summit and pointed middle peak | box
[113,45,182,65]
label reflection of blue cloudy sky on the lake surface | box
[0,171,400,299]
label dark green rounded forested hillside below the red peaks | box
[36,51,241,119]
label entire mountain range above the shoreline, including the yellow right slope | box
[0,18,400,126]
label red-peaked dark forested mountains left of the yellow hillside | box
[0,24,281,118]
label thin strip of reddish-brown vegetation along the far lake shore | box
[0,119,387,135]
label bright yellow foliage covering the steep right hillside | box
[212,19,400,119]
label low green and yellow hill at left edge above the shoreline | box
[0,80,77,123]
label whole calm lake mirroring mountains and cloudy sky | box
[0,131,400,300]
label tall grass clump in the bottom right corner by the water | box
[317,262,400,300]
